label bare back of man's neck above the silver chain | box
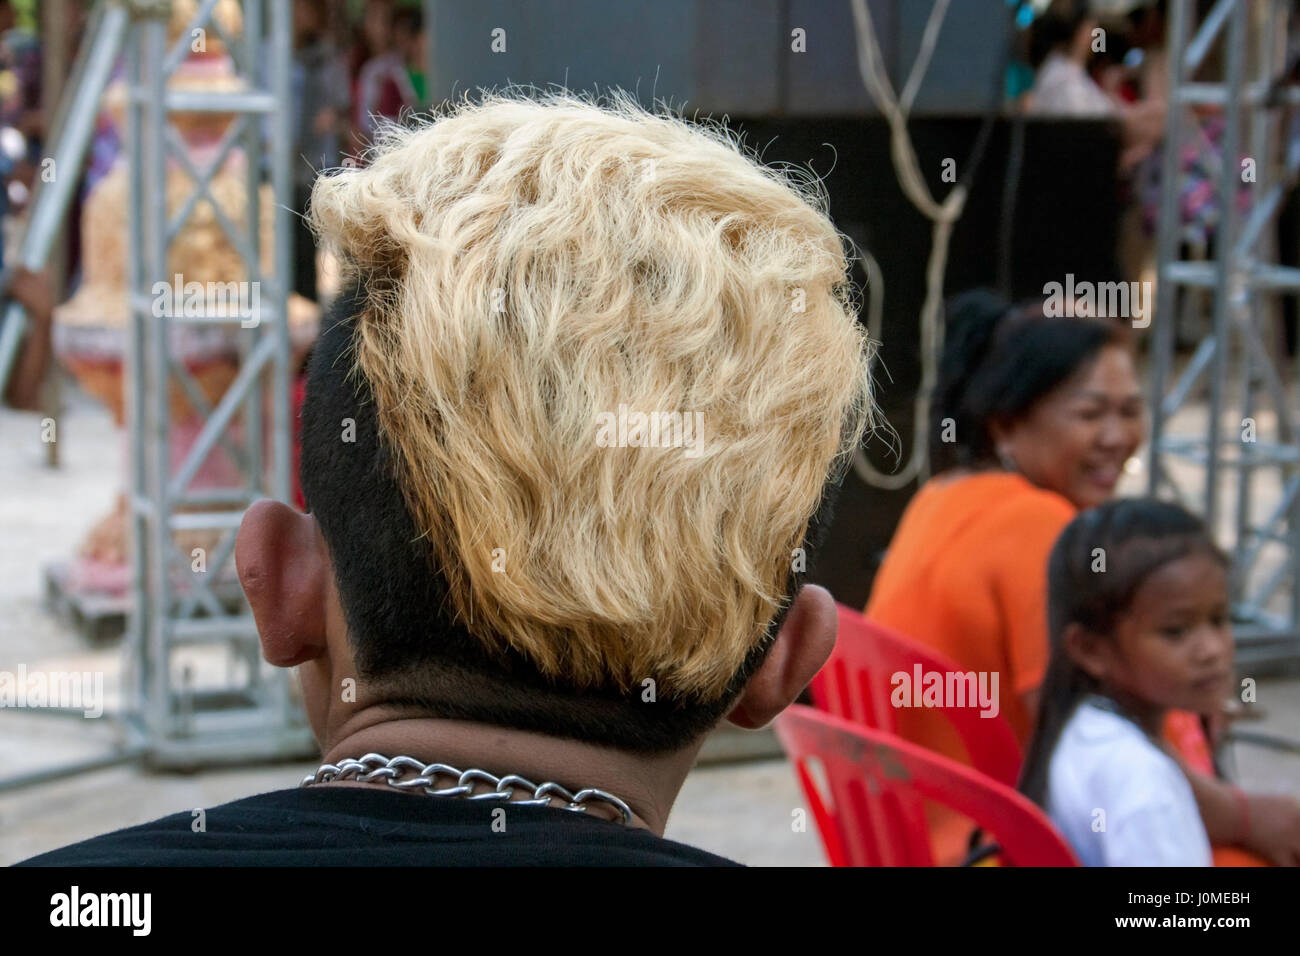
[313,705,702,836]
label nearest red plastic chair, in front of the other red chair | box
[776,704,1079,866]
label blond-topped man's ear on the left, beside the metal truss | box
[235,499,330,667]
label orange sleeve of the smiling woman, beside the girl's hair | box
[989,494,1075,695]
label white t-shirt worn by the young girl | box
[1048,698,1212,866]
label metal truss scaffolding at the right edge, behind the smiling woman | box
[1149,0,1300,667]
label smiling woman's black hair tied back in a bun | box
[930,289,1128,472]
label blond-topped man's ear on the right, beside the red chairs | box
[727,584,839,730]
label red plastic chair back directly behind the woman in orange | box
[809,604,1023,787]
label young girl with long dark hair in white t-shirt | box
[1021,499,1232,866]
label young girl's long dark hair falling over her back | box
[1021,498,1229,806]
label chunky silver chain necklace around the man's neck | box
[299,753,632,826]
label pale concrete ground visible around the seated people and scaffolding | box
[0,388,1300,866]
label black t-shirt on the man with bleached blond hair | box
[18,787,738,866]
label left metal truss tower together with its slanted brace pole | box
[0,0,316,790]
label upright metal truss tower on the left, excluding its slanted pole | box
[127,0,312,766]
